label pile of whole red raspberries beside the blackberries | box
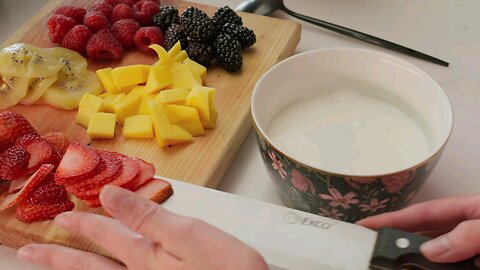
[47,0,164,60]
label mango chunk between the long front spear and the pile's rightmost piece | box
[164,104,205,136]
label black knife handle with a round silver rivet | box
[370,228,480,270]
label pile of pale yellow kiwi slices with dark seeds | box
[0,43,101,110]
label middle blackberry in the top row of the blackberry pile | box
[180,7,215,41]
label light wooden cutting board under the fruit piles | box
[0,0,301,253]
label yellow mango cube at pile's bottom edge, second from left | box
[123,115,153,139]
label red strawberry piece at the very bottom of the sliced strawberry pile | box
[16,200,75,223]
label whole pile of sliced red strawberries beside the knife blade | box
[0,111,173,223]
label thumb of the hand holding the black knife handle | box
[420,220,480,263]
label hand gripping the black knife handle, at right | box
[357,195,480,263]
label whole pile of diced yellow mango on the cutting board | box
[76,42,218,147]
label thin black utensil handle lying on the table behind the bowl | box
[282,6,449,67]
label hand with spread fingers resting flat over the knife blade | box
[18,186,268,270]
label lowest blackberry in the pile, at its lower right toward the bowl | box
[214,33,243,72]
